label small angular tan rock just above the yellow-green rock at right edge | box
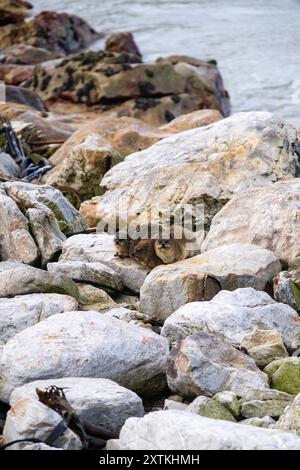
[241,329,288,368]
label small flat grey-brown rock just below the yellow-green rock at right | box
[241,390,293,418]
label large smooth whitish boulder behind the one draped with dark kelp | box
[0,312,169,402]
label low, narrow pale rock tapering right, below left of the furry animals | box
[47,261,123,291]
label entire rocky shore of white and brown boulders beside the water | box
[0,0,300,450]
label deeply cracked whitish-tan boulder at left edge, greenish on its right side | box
[0,182,86,266]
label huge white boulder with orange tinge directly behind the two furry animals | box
[93,112,298,228]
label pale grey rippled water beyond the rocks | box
[33,0,300,125]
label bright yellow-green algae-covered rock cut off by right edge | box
[264,357,300,395]
